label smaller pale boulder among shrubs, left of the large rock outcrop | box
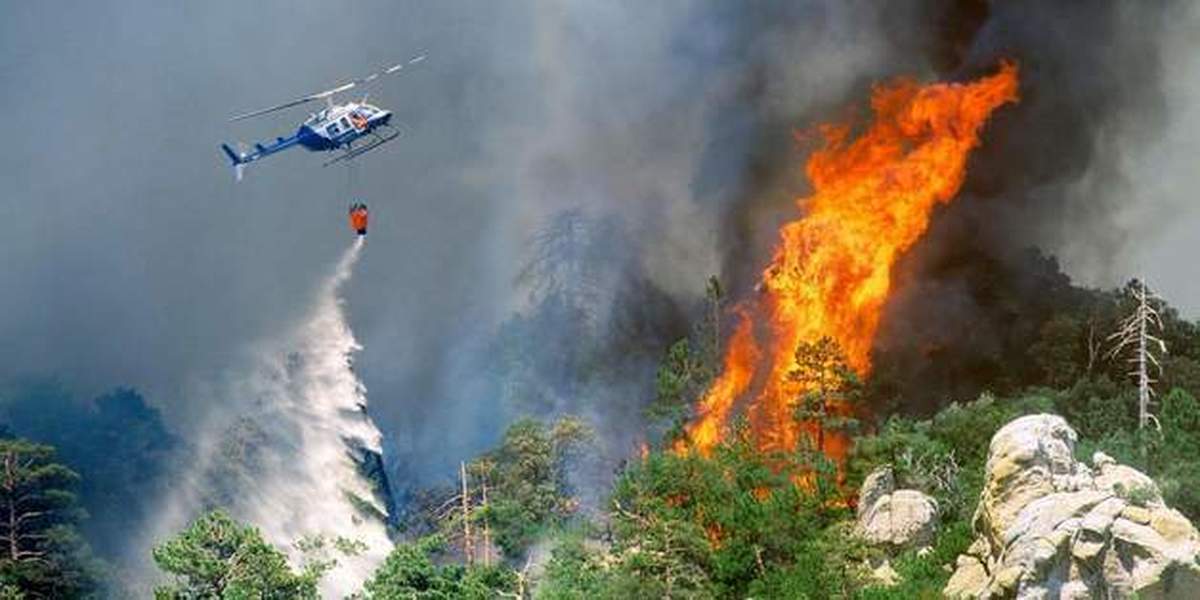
[858,467,937,550]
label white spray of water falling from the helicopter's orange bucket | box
[143,238,391,598]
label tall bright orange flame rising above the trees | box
[677,62,1018,458]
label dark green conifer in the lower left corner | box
[0,438,103,598]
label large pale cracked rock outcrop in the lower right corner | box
[944,414,1200,599]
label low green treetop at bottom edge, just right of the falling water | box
[364,536,518,600]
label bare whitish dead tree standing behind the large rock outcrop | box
[1109,280,1166,428]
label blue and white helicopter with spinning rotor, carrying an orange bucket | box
[221,54,425,181]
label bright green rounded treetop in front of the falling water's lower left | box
[154,511,332,600]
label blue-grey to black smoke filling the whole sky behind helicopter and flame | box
[0,0,1200,580]
